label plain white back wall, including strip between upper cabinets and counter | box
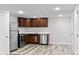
[19,17,72,44]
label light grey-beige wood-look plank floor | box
[10,44,73,55]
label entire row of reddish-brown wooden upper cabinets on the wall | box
[18,17,48,27]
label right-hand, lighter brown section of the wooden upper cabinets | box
[31,18,48,27]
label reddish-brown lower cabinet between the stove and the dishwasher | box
[25,34,40,44]
